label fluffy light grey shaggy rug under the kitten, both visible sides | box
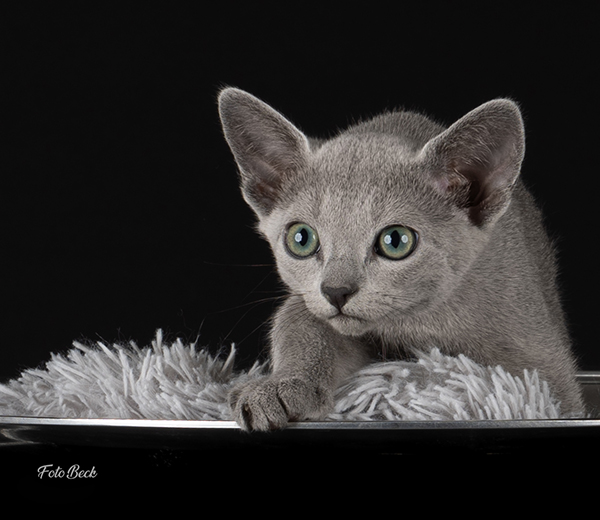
[0,331,561,421]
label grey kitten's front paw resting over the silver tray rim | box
[229,377,332,431]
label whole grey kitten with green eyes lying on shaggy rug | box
[219,88,582,430]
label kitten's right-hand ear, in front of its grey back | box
[423,99,525,226]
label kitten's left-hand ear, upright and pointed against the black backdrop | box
[219,88,309,216]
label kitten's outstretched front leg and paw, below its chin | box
[229,296,370,431]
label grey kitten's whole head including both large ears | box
[219,88,524,335]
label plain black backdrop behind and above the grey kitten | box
[0,2,600,381]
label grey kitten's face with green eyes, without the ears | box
[259,136,488,335]
